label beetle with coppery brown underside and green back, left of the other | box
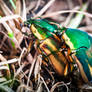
[24,19,73,76]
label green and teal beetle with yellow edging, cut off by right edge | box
[61,28,92,82]
